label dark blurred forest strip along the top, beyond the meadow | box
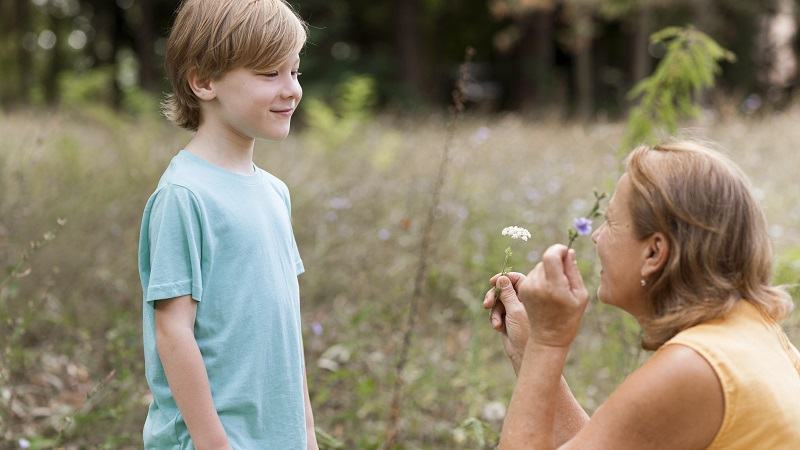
[0,0,800,114]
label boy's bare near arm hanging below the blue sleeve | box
[155,295,231,450]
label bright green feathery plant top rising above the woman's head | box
[621,26,735,152]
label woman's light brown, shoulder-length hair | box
[626,141,794,350]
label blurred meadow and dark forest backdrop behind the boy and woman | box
[0,0,800,449]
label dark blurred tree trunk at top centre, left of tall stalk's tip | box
[392,0,424,97]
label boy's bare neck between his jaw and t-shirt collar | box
[185,116,255,175]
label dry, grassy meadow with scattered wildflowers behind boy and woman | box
[0,104,800,449]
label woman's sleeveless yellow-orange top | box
[665,300,800,450]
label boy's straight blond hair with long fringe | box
[162,0,306,131]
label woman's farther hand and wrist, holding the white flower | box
[483,272,530,373]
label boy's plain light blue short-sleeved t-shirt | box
[139,150,306,450]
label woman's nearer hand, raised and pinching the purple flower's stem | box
[517,244,589,347]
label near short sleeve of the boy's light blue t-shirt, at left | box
[144,185,203,302]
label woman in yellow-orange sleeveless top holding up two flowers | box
[484,142,800,450]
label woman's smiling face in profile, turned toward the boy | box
[592,174,650,317]
